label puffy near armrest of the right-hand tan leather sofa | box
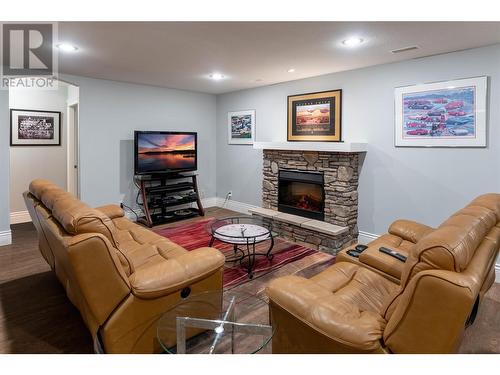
[266,275,386,352]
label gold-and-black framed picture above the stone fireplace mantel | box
[287,90,342,142]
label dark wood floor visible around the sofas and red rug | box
[0,209,500,353]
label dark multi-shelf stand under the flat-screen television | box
[134,173,205,228]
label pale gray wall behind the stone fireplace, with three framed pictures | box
[217,45,500,234]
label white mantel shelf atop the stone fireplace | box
[253,142,368,153]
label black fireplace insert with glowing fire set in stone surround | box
[278,170,325,221]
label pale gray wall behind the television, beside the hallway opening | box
[62,75,216,206]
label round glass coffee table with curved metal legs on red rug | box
[207,216,274,279]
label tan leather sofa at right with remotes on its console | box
[266,194,500,353]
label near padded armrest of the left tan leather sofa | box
[129,247,225,299]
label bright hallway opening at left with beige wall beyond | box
[9,80,80,224]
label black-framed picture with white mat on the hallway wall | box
[10,109,61,146]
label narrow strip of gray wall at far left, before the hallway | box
[0,90,10,236]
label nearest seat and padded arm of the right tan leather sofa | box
[266,262,398,350]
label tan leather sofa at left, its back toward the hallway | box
[24,180,224,353]
